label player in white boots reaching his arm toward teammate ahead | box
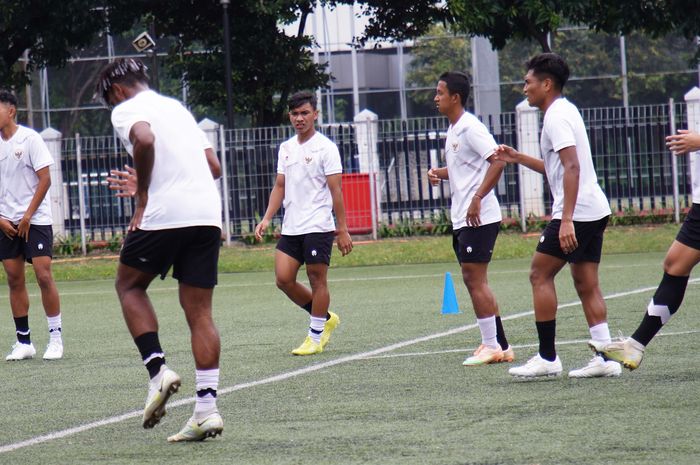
[496,53,622,378]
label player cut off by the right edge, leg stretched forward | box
[591,129,700,370]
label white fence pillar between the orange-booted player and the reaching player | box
[515,100,544,232]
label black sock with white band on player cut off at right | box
[632,273,688,346]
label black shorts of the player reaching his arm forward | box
[537,216,609,263]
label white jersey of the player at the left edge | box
[0,125,53,226]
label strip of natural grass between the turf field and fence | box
[0,224,678,282]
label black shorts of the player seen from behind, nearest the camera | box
[119,226,221,289]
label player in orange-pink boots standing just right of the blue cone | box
[428,72,515,366]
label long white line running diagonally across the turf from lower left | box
[0,278,700,454]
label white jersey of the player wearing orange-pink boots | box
[445,112,501,230]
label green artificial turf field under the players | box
[0,253,700,465]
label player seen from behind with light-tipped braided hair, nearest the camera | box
[96,58,223,442]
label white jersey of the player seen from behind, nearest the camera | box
[112,90,221,231]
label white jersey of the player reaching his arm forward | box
[540,97,610,221]
